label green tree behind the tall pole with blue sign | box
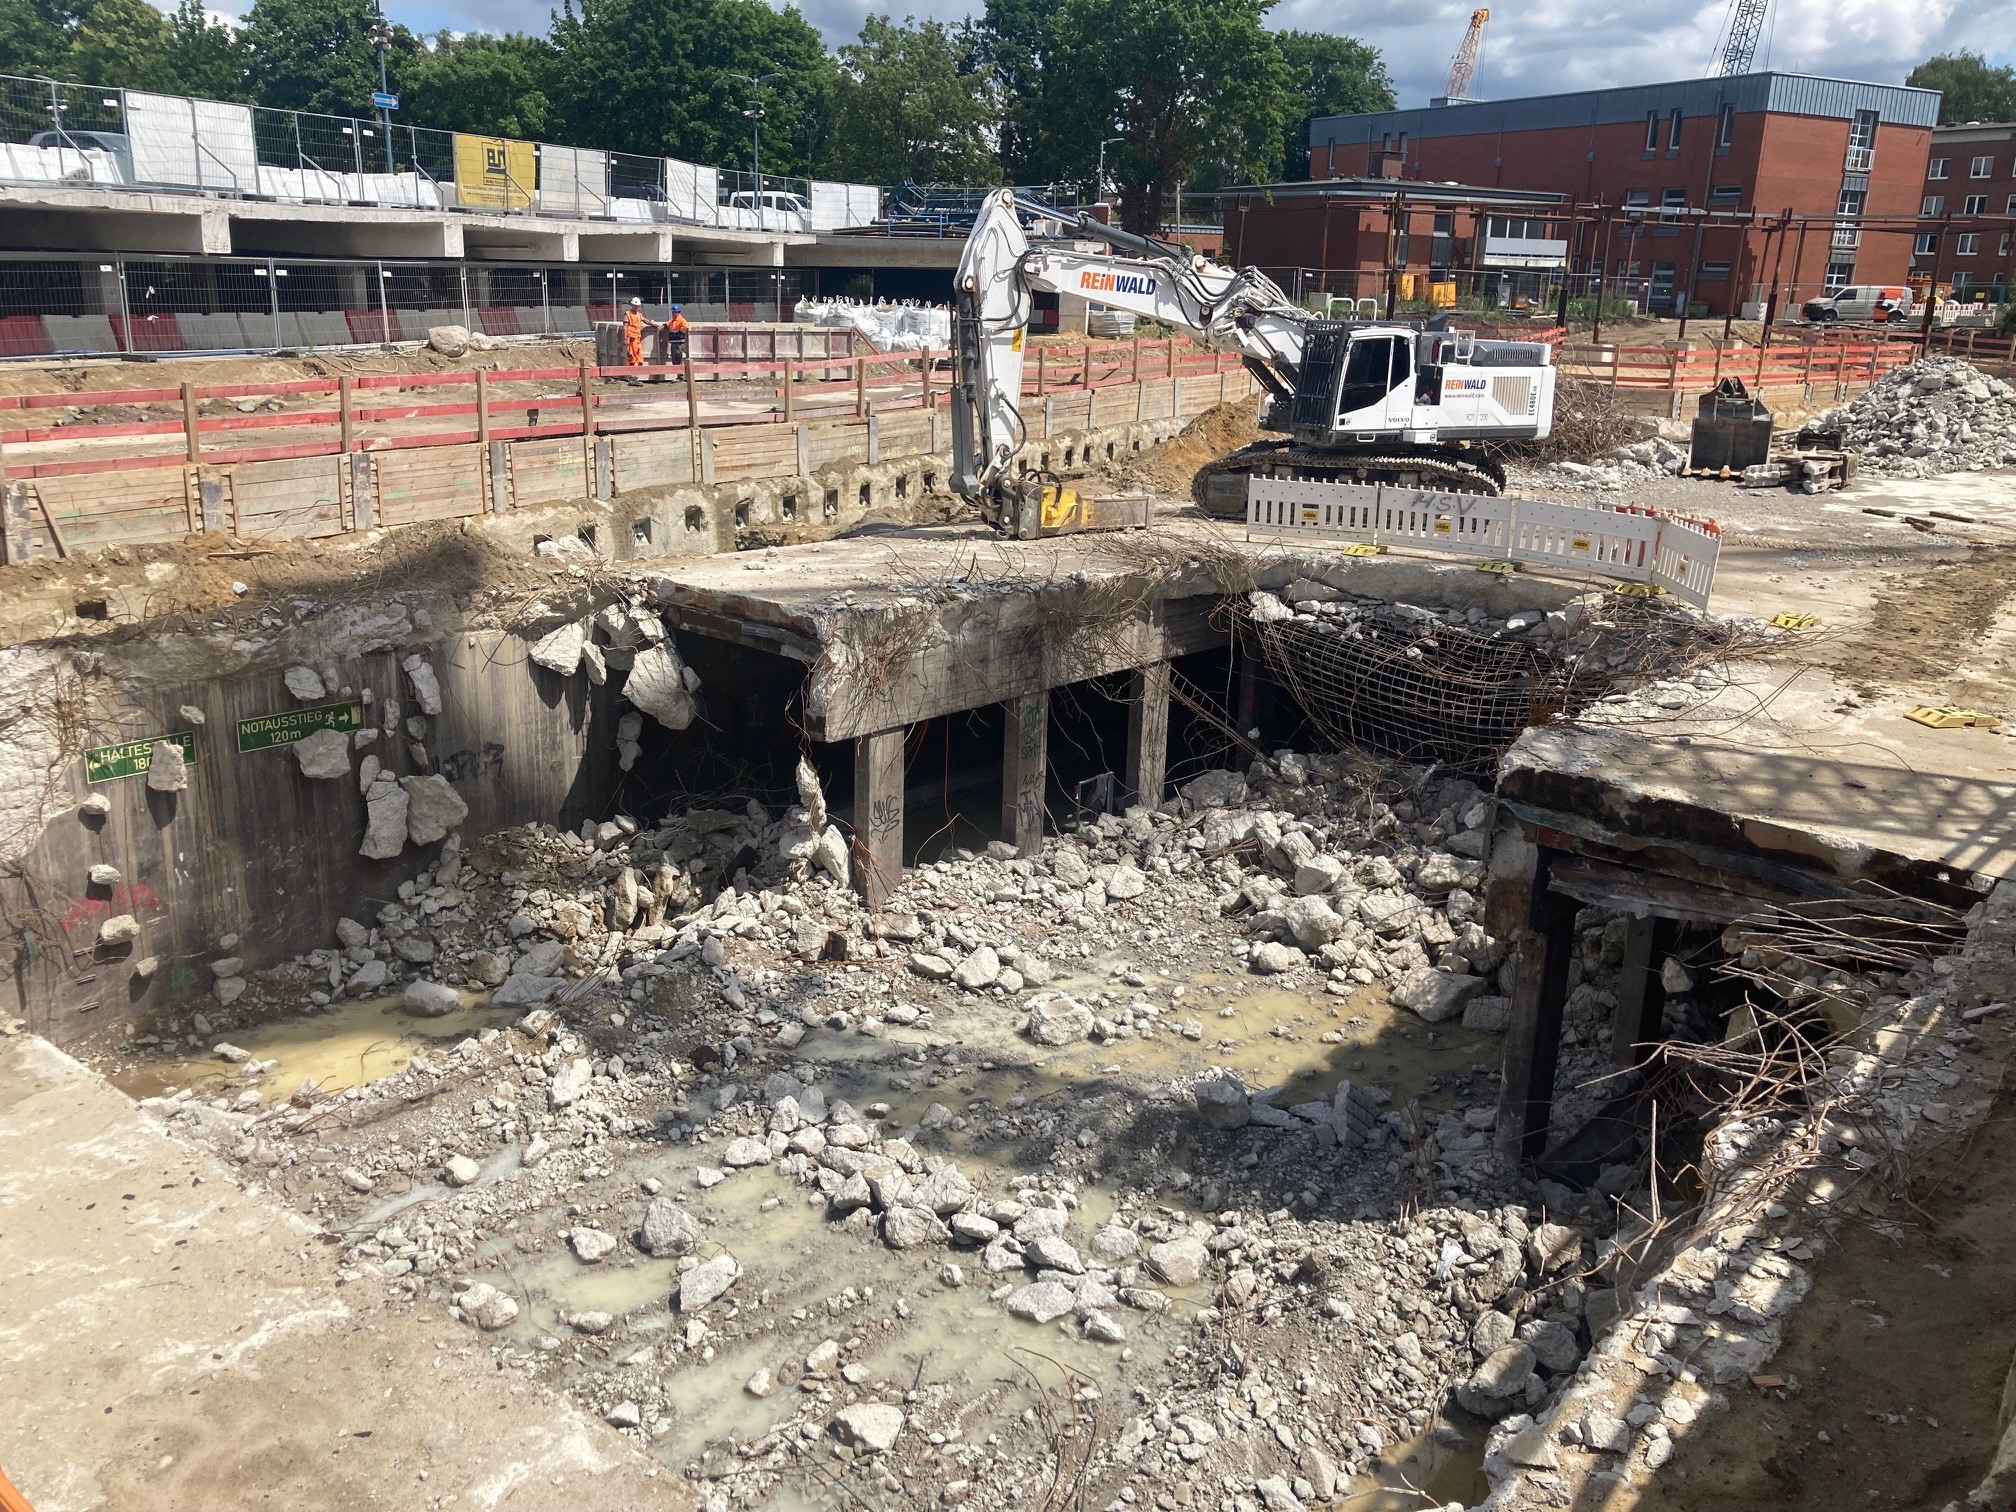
[244,0,419,115]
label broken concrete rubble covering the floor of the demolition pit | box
[110,741,1685,1506]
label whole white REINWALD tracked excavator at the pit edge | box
[952,190,1554,538]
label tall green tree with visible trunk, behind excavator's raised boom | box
[1042,0,1296,234]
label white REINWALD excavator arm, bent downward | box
[952,190,1308,524]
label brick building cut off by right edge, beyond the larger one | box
[1911,123,2016,302]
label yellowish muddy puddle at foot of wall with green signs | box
[111,992,520,1103]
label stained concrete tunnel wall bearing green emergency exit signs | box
[0,631,617,1044]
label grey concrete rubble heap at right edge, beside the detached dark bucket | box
[1812,357,2016,478]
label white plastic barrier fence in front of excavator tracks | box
[1246,478,1722,609]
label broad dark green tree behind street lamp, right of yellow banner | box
[552,0,831,173]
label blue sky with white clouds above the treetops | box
[212,0,2016,105]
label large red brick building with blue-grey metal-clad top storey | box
[1226,73,1939,314]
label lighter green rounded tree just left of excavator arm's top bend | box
[827,14,1000,183]
